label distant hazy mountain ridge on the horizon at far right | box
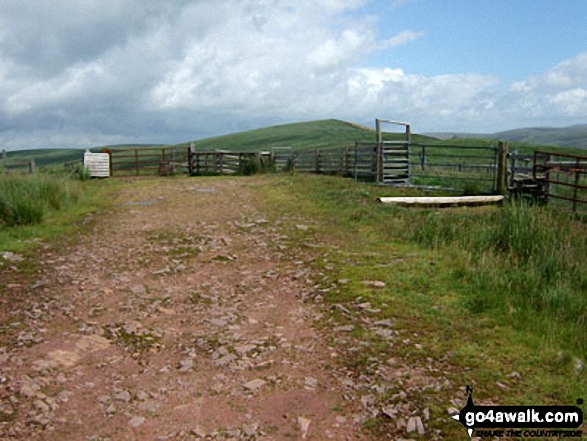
[426,124,587,150]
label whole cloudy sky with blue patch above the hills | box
[0,0,587,151]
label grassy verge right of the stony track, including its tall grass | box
[252,173,587,439]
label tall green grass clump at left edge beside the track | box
[0,174,83,227]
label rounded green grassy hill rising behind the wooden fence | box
[172,119,432,151]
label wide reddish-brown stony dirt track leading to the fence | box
[0,179,372,441]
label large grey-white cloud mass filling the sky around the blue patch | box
[0,0,587,147]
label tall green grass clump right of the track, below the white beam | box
[405,203,587,355]
